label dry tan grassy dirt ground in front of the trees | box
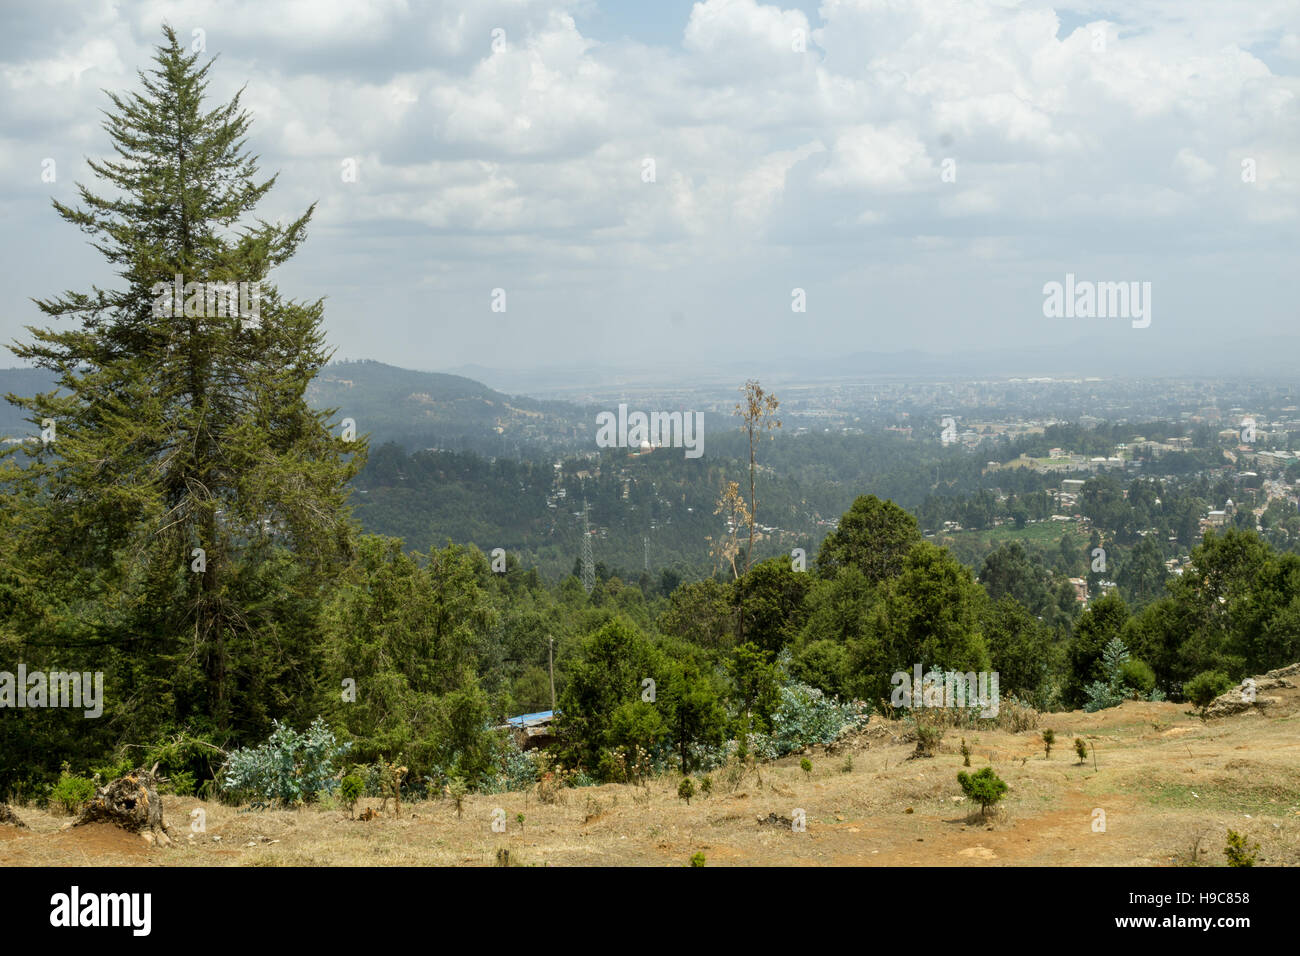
[0,691,1300,866]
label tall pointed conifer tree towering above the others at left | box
[0,27,365,741]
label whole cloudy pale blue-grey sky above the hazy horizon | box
[0,0,1300,371]
